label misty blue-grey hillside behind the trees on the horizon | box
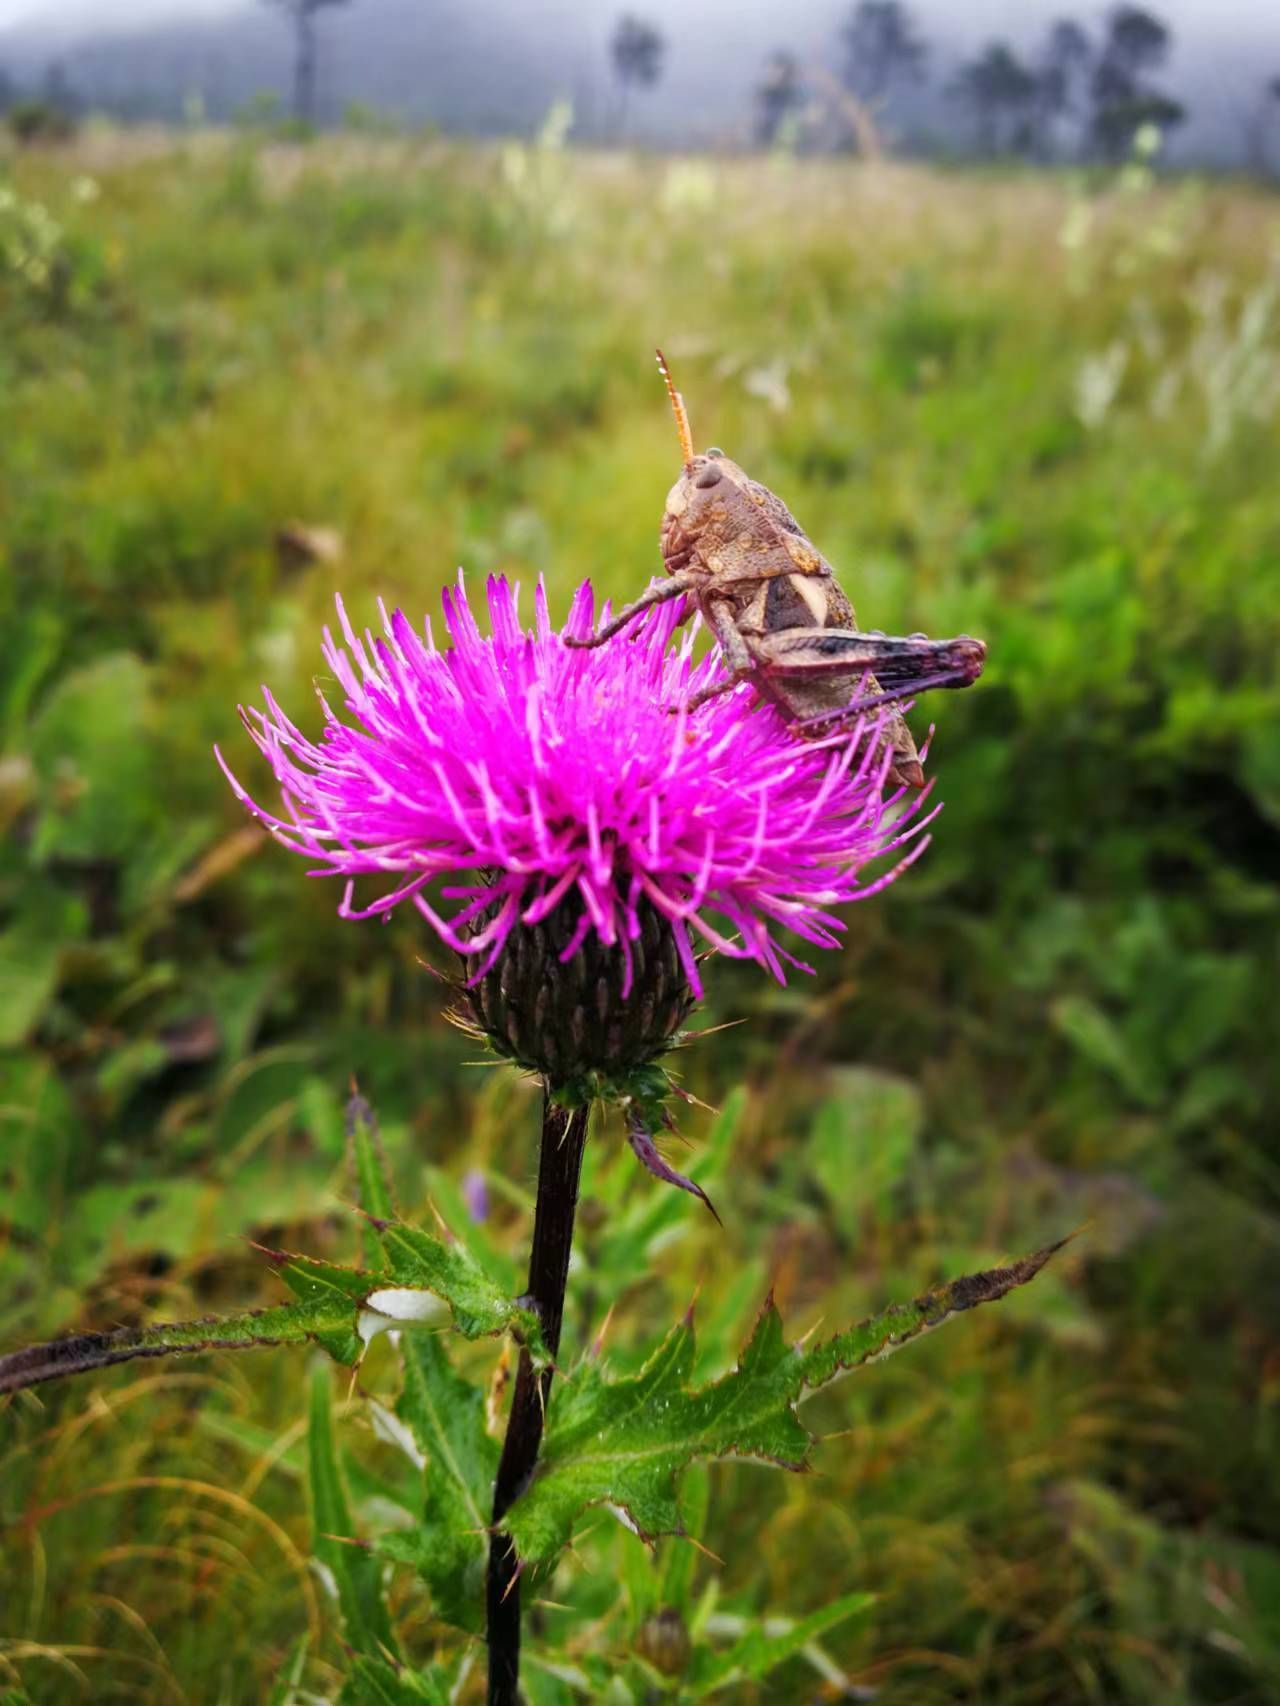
[0,0,1280,165]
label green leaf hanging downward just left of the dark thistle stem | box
[381,1332,498,1633]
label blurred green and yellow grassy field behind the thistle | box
[0,131,1280,1706]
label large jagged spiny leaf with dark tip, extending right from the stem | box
[505,1240,1065,1564]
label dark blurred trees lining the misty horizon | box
[0,0,1280,174]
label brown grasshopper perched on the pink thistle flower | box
[567,350,986,788]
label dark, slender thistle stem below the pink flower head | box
[486,1083,587,1706]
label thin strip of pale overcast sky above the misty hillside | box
[0,0,1280,44]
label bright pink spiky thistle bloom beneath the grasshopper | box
[218,578,934,993]
